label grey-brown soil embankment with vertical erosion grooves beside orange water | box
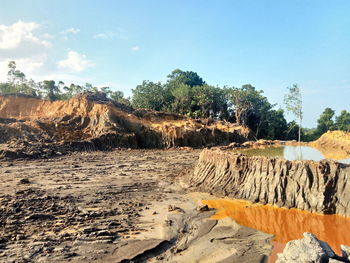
[189,149,350,216]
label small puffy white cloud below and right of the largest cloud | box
[57,50,94,72]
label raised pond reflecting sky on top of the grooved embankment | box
[234,145,350,164]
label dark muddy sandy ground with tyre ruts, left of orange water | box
[0,150,271,262]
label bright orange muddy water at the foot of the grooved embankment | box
[202,199,350,262]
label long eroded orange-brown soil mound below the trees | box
[0,93,251,156]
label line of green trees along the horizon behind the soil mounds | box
[0,61,350,141]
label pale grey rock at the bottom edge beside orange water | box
[276,232,336,263]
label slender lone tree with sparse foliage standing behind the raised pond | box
[284,84,303,142]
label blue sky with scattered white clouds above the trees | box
[0,0,350,127]
